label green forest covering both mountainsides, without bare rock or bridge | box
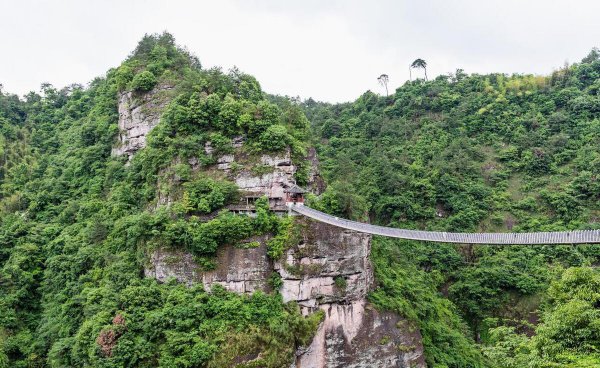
[0,33,600,367]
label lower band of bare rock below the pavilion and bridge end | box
[145,218,425,368]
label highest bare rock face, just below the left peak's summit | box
[112,85,173,160]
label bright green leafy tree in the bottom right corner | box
[483,267,600,368]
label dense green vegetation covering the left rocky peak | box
[0,34,321,367]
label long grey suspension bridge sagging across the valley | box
[292,206,600,245]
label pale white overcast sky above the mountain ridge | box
[0,0,600,102]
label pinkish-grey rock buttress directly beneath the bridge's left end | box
[284,218,426,368]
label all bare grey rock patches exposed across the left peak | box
[113,86,425,368]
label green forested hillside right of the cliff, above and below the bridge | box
[305,50,600,367]
